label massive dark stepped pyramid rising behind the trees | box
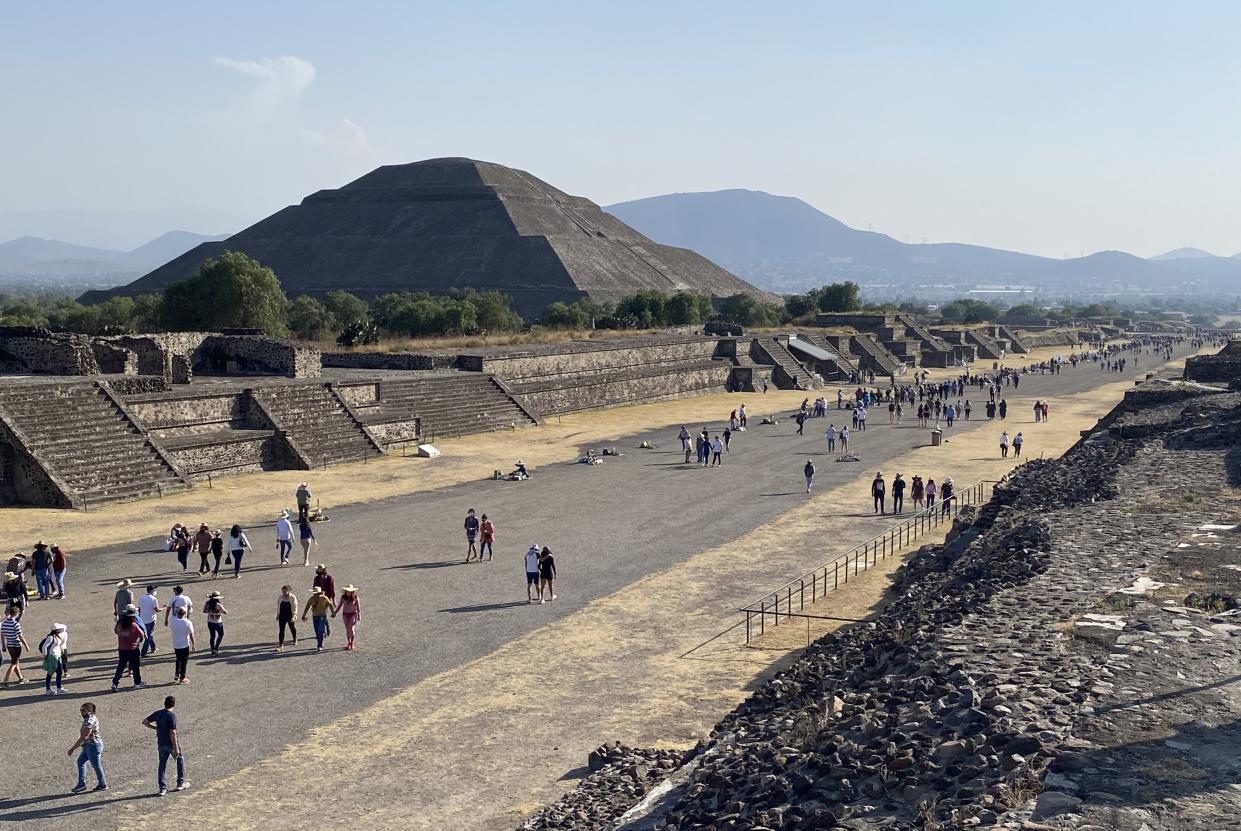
[83,159,762,315]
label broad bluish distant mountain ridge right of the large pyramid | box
[604,190,1241,293]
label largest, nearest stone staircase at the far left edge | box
[0,384,192,509]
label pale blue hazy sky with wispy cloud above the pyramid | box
[0,0,1241,257]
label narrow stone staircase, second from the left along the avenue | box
[252,383,383,468]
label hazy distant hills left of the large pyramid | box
[0,231,225,279]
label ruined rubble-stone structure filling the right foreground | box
[520,347,1241,831]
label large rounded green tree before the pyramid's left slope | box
[159,251,288,335]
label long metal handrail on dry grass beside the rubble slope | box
[741,479,997,646]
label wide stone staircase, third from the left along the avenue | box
[380,372,539,437]
